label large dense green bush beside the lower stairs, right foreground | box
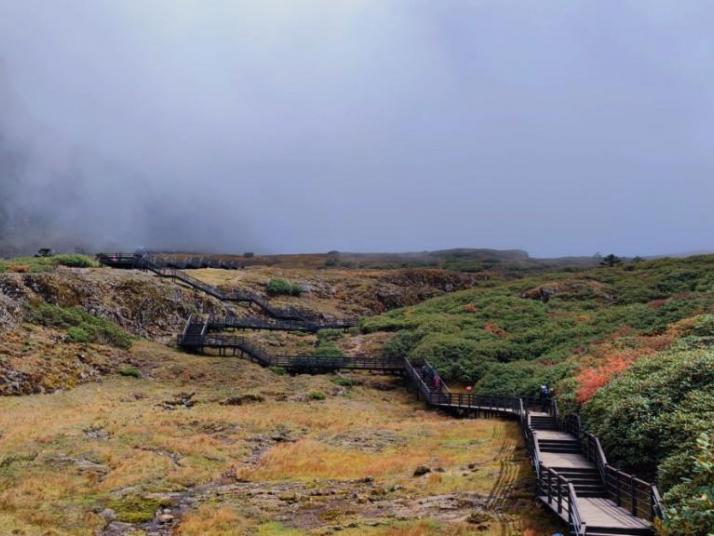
[582,346,714,536]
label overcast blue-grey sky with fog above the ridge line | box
[0,0,714,256]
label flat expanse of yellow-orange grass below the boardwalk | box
[0,342,556,536]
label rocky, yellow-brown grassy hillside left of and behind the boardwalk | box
[0,259,560,536]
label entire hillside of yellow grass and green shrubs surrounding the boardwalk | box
[0,256,714,535]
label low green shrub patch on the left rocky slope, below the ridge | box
[32,303,131,348]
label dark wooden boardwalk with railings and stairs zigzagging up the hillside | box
[100,254,662,536]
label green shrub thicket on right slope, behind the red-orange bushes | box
[360,256,714,397]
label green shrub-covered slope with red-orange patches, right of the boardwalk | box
[362,256,714,535]
